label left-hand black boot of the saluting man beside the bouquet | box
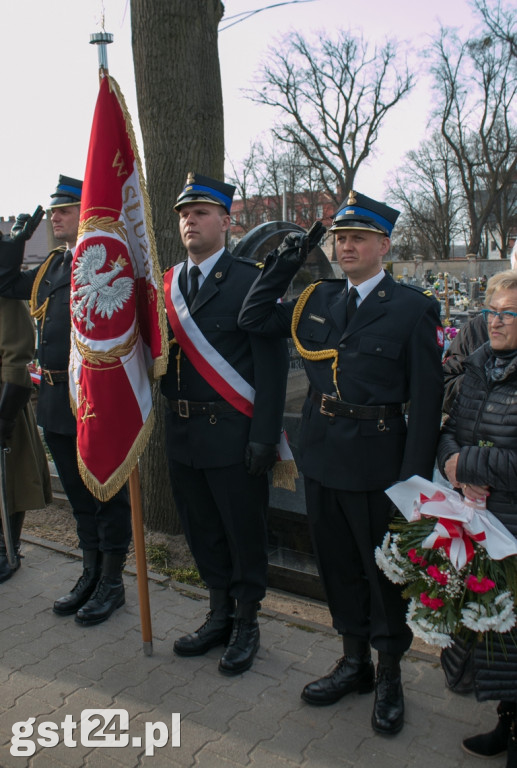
[302,654,375,706]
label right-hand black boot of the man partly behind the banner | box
[75,552,126,627]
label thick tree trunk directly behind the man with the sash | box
[131,0,224,533]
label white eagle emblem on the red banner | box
[71,243,133,330]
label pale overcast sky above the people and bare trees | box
[0,0,480,217]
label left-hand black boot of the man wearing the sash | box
[173,589,235,656]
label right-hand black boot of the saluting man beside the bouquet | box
[372,652,404,736]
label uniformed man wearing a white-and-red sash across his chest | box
[161,174,288,674]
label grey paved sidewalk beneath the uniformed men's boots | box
[0,540,496,768]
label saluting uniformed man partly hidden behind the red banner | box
[0,176,131,626]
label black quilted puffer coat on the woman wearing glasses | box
[438,342,517,701]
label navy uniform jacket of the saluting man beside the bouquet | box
[239,258,443,491]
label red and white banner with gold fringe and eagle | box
[69,75,168,501]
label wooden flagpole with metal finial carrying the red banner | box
[90,29,153,656]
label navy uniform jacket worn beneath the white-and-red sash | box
[161,251,288,468]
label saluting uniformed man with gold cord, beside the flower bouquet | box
[239,192,443,734]
